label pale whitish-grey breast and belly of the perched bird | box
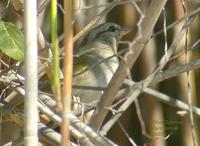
[73,42,119,103]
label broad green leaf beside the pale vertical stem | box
[0,22,24,61]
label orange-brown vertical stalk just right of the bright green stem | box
[61,0,73,146]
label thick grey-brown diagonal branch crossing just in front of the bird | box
[91,0,166,130]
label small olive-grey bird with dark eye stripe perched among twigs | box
[73,22,127,109]
